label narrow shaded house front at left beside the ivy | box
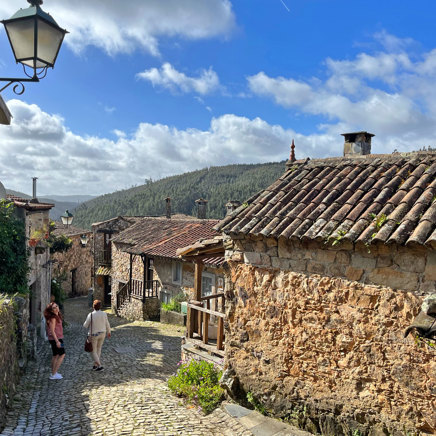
[7,195,54,337]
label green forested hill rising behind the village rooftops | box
[74,161,285,228]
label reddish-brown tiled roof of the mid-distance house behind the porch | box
[112,217,218,259]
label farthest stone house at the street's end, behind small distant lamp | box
[51,222,94,297]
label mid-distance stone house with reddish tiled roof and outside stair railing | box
[111,216,224,319]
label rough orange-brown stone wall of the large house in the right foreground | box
[225,237,436,436]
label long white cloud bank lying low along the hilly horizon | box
[0,100,300,194]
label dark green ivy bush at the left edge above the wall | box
[0,200,29,294]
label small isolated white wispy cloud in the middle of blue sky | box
[136,62,219,95]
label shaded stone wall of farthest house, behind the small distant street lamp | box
[52,233,94,296]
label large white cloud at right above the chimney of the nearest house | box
[247,32,436,137]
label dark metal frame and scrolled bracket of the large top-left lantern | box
[0,0,68,95]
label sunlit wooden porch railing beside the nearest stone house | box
[186,294,226,350]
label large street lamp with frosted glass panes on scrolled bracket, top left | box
[0,0,68,95]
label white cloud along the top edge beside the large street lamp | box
[0,0,235,55]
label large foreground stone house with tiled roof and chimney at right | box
[215,132,436,435]
